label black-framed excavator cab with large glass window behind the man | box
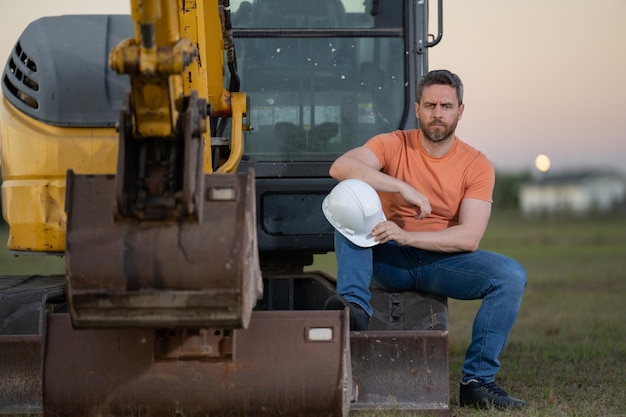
[231,0,438,267]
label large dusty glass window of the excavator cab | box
[231,0,407,162]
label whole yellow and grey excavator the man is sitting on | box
[0,0,450,417]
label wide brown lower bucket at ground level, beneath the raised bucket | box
[44,311,353,417]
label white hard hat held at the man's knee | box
[322,179,387,247]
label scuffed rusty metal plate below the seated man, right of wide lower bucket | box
[350,330,450,416]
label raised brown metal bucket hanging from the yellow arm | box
[66,171,262,328]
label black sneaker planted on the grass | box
[459,379,528,408]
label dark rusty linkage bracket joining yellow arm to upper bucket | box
[113,91,207,221]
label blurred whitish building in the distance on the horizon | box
[519,171,626,215]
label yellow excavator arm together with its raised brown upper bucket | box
[65,0,262,328]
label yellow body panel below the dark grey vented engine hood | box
[0,99,118,252]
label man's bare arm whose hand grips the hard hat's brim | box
[372,198,491,252]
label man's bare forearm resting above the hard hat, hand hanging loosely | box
[329,146,431,219]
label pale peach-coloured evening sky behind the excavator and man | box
[0,0,626,173]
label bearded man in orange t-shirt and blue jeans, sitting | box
[326,70,526,408]
